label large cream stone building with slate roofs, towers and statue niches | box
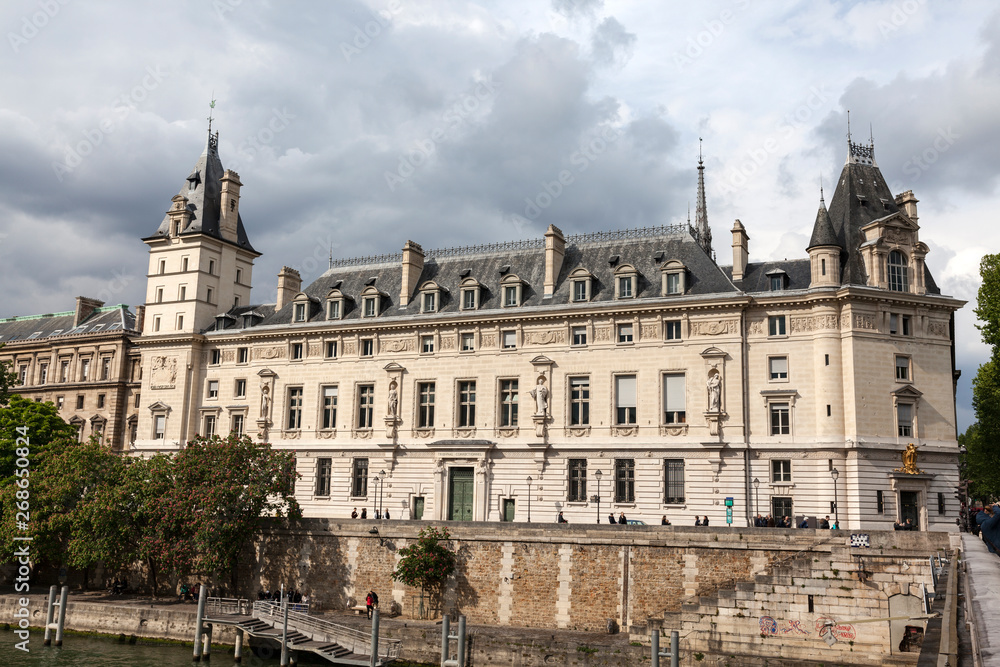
[135,130,963,530]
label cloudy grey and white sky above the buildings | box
[0,0,1000,430]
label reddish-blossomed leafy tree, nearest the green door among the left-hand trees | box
[168,434,302,592]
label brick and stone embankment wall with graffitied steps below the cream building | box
[247,519,949,664]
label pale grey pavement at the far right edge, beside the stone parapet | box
[962,533,1000,667]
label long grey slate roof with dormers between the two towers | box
[249,225,739,325]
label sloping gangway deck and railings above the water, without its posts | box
[204,598,402,667]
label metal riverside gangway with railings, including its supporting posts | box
[195,596,402,667]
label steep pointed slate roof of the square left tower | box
[149,133,257,252]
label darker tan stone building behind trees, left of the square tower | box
[0,296,142,450]
